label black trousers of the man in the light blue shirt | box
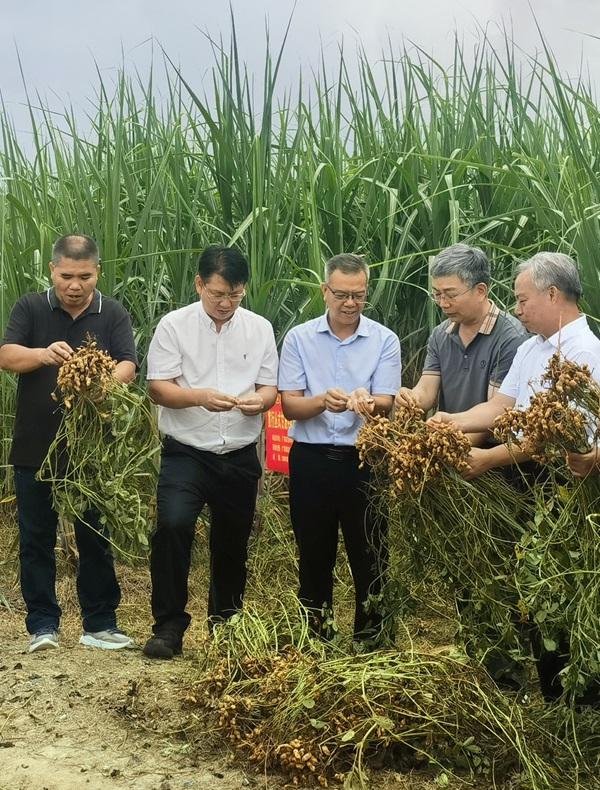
[289,442,387,639]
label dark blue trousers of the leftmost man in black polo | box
[14,466,121,634]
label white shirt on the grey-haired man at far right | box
[498,315,600,409]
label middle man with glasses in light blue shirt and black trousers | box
[279,254,400,640]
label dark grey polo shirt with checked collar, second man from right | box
[423,302,530,413]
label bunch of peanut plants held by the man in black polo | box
[39,338,159,558]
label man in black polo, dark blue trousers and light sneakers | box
[0,235,137,652]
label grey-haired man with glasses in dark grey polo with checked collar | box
[396,244,528,445]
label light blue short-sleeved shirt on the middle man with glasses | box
[279,315,401,445]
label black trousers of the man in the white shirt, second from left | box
[150,436,262,634]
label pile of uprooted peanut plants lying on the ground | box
[172,607,597,788]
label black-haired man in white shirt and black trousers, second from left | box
[144,245,277,658]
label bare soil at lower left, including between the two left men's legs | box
[0,515,440,790]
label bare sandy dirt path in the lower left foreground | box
[0,609,281,790]
